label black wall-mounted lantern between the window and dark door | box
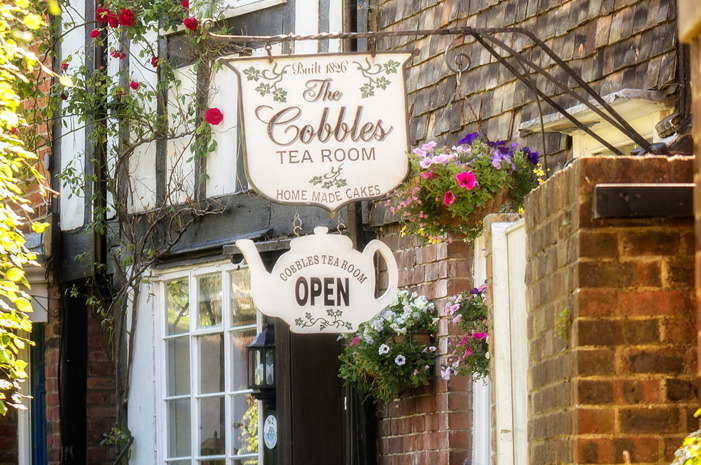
[246,323,275,407]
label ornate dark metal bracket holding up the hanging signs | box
[203,20,666,155]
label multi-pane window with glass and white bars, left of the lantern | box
[160,265,260,465]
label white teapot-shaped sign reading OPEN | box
[236,226,398,333]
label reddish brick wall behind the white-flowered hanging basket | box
[372,216,473,465]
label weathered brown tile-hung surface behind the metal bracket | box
[370,0,677,171]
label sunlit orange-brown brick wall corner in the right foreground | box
[525,157,698,465]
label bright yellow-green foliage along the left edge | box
[0,0,70,415]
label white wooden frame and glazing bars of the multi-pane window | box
[152,261,263,465]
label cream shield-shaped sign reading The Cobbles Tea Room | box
[224,52,412,210]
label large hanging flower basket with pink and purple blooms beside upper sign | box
[387,133,544,243]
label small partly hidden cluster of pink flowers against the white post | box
[441,285,489,379]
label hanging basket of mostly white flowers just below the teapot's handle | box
[338,291,438,402]
